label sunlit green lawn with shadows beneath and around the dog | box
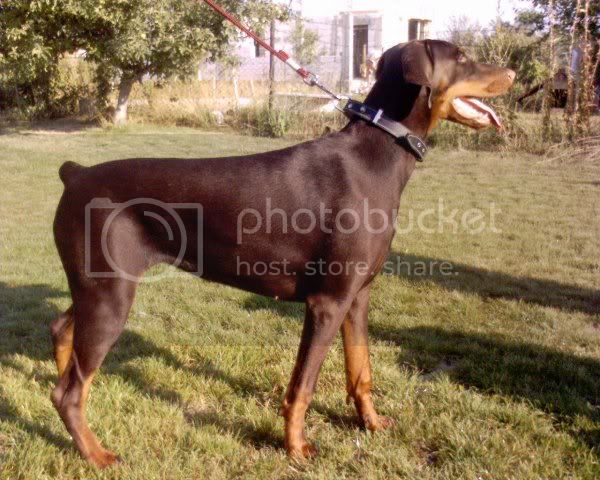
[0,125,600,480]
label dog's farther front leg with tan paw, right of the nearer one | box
[342,288,393,431]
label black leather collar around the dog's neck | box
[344,100,427,162]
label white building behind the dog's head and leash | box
[207,0,439,89]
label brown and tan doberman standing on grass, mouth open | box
[52,40,515,467]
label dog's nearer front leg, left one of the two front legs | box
[282,295,350,458]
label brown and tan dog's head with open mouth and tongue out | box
[377,40,516,131]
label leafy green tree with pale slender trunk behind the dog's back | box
[73,0,283,124]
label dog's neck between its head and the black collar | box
[365,78,431,139]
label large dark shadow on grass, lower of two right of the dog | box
[369,324,600,454]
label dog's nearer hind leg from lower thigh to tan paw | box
[52,279,135,468]
